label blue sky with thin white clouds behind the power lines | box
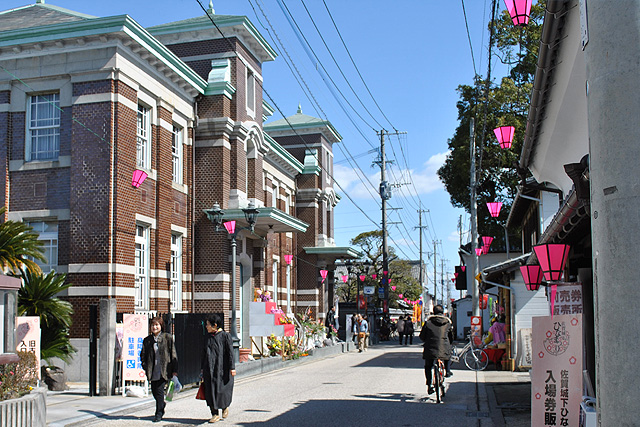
[2,0,504,298]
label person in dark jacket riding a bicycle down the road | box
[420,304,453,394]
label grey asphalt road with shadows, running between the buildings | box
[83,344,493,427]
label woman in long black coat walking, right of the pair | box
[201,314,236,423]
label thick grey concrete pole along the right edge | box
[584,0,640,426]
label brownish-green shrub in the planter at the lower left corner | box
[0,351,38,400]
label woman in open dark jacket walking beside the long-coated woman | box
[140,317,178,423]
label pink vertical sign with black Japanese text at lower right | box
[531,314,582,427]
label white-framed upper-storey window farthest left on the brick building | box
[25,92,60,161]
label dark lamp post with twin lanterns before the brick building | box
[205,202,258,363]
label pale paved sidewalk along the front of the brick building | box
[47,344,355,427]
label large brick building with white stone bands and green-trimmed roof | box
[0,0,357,358]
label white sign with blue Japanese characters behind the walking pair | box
[122,314,149,381]
